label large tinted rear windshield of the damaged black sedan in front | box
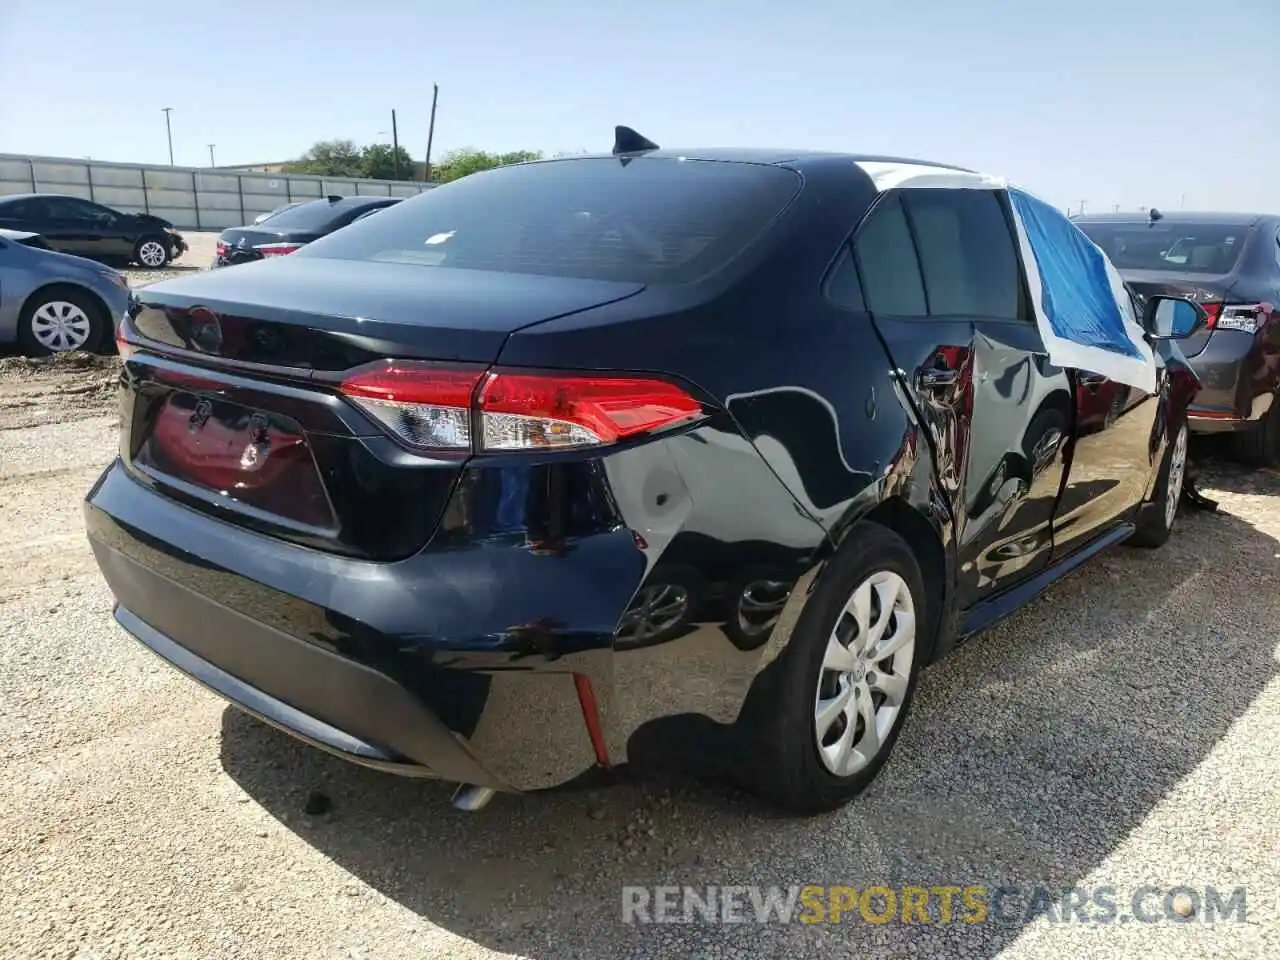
[297,157,800,284]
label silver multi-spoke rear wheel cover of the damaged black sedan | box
[813,570,915,777]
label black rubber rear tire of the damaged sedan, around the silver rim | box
[742,522,932,814]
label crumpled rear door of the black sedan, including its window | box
[854,189,1071,608]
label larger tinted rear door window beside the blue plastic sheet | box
[905,189,1021,320]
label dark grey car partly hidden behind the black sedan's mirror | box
[1074,210,1280,466]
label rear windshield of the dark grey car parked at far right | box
[1076,220,1249,274]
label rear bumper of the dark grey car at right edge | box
[1187,330,1277,433]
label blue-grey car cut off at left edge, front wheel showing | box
[0,229,129,356]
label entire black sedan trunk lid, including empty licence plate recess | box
[120,257,644,559]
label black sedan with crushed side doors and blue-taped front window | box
[94,131,1204,812]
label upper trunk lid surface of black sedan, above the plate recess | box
[134,257,644,371]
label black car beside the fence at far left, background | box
[0,193,187,269]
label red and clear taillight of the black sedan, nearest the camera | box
[340,361,703,451]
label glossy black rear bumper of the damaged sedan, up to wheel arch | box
[84,407,829,791]
